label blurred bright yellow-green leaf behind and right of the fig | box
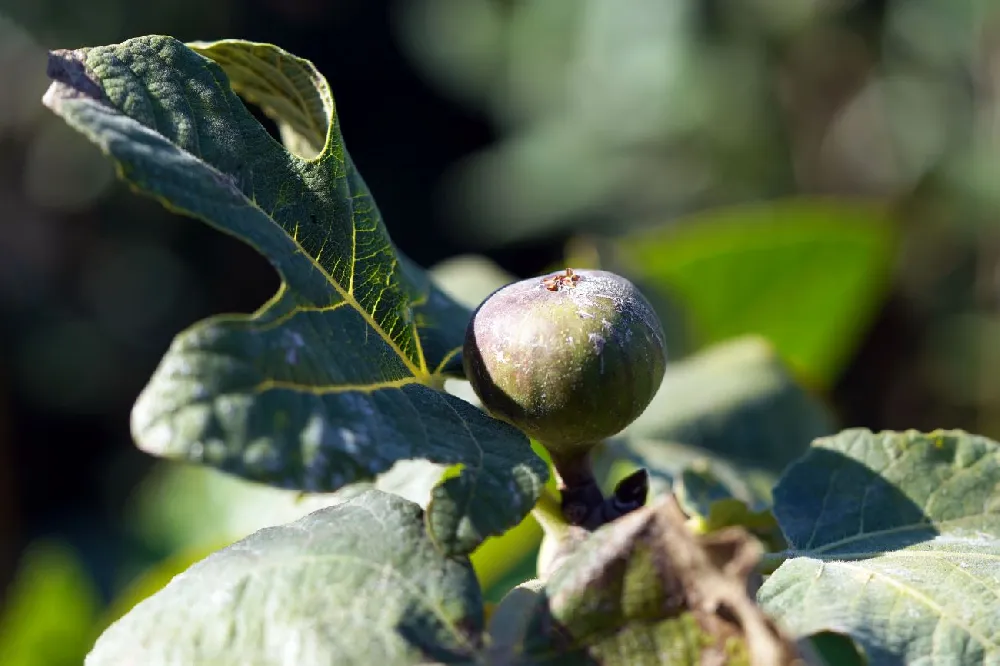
[615,199,895,385]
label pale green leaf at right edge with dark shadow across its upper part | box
[759,429,1000,665]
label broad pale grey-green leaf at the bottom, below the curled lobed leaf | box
[86,490,483,666]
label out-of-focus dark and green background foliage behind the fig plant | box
[0,0,1000,666]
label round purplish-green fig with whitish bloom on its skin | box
[463,269,666,461]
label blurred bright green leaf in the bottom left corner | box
[0,541,99,666]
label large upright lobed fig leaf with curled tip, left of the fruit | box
[44,36,547,553]
